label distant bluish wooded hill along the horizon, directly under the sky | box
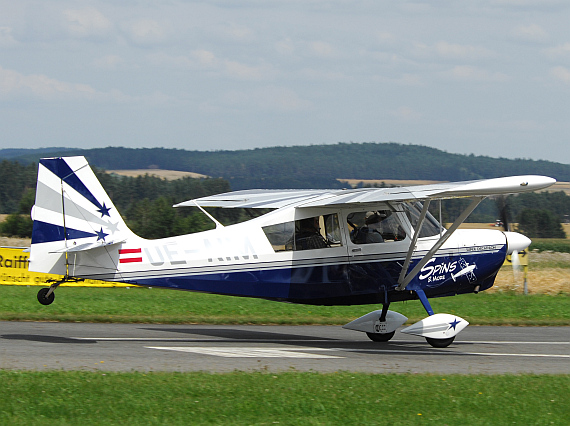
[8,143,570,190]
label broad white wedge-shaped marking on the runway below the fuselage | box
[146,346,344,359]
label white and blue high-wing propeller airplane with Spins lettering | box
[29,156,556,348]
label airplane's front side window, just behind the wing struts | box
[347,210,406,244]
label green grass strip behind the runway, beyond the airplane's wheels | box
[0,286,570,326]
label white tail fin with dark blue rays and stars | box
[30,157,138,276]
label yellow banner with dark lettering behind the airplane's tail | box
[0,247,133,287]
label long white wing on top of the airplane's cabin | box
[174,175,556,208]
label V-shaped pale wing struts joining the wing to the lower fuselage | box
[396,197,485,291]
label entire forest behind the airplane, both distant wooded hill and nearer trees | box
[0,143,570,238]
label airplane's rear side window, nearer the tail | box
[263,214,342,252]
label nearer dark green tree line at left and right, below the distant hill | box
[0,160,570,238]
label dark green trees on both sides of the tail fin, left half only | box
[0,160,233,238]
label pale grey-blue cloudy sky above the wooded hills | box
[0,0,570,164]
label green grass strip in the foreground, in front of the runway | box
[0,371,570,425]
